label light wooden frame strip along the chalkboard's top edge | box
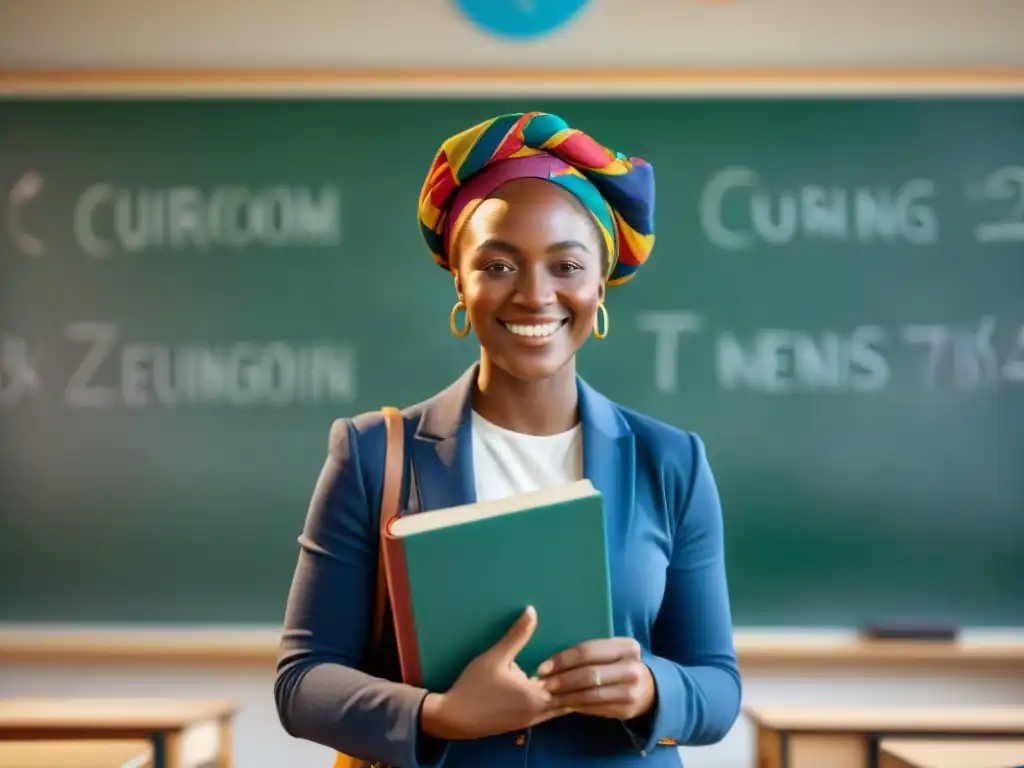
[0,67,1024,630]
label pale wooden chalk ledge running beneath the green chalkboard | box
[0,625,1024,673]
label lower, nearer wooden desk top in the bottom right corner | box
[879,738,1024,768]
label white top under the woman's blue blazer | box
[472,411,583,502]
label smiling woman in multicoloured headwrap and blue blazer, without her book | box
[274,113,740,768]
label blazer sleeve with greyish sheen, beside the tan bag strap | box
[274,420,447,768]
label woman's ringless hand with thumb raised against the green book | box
[420,607,568,739]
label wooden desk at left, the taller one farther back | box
[0,698,238,768]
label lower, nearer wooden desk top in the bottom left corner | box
[0,740,153,768]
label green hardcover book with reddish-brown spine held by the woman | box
[384,480,613,691]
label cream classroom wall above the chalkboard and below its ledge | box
[0,0,1024,768]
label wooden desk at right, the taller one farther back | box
[744,707,1024,768]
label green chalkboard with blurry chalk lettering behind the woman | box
[0,98,1024,627]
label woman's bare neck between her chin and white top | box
[473,353,580,435]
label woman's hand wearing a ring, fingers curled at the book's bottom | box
[537,637,656,720]
